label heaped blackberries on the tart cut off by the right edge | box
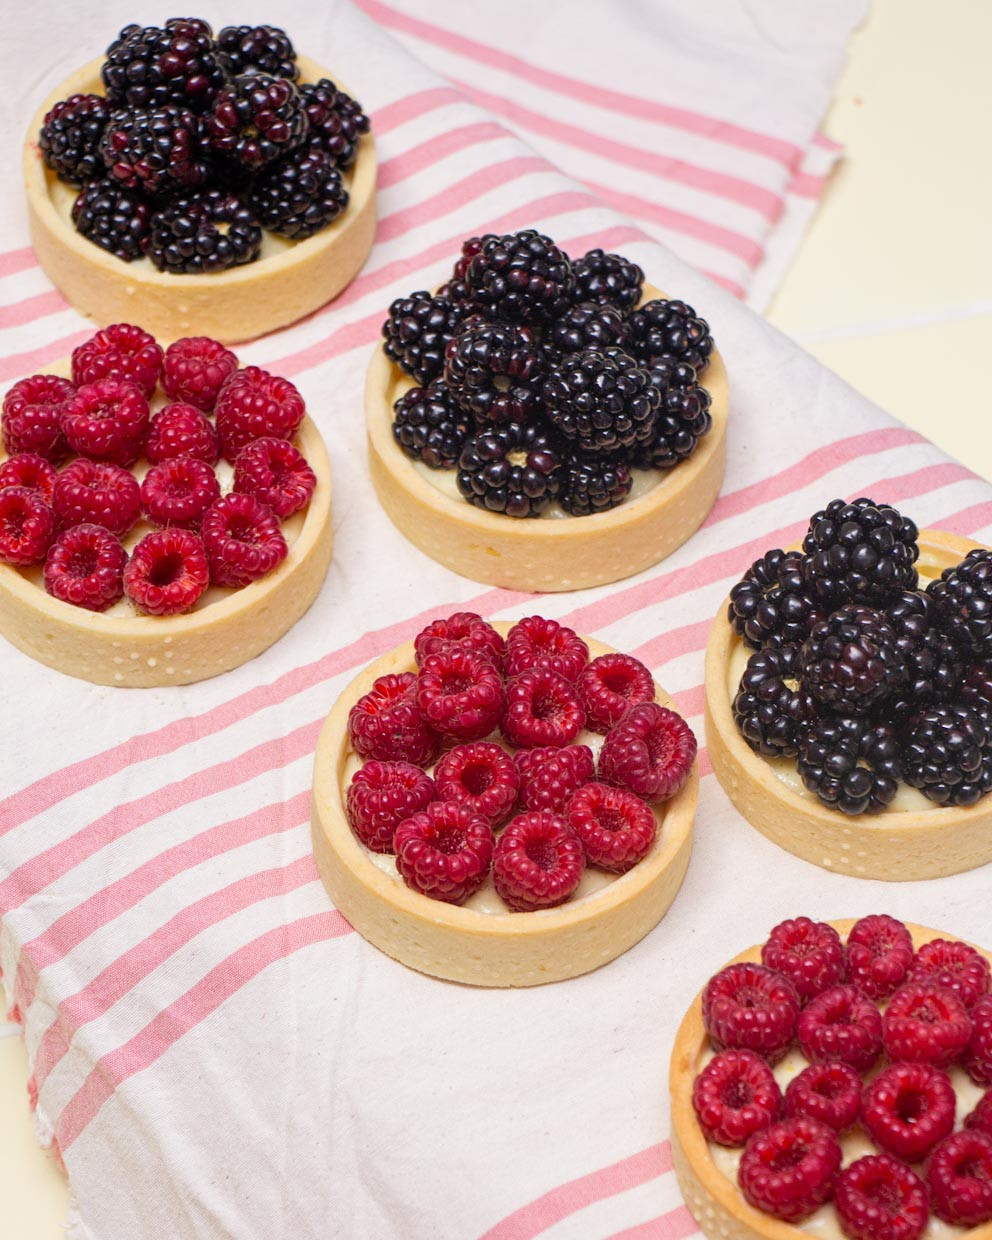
[728,497,992,815]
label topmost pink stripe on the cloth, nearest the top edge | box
[358,0,803,167]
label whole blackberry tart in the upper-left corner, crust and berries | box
[22,17,376,343]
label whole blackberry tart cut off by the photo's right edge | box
[706,496,992,880]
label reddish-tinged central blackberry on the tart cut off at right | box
[800,605,906,714]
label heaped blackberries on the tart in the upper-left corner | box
[38,17,368,273]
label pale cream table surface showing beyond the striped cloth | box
[0,0,992,1225]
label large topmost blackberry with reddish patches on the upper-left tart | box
[100,17,224,113]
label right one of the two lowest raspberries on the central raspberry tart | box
[492,810,585,913]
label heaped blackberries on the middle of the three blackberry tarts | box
[382,229,713,517]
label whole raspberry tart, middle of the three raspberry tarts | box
[311,613,698,987]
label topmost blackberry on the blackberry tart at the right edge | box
[802,496,920,606]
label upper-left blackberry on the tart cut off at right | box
[727,549,823,650]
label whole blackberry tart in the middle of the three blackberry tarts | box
[366,229,728,593]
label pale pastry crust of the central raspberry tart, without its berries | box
[311,622,698,987]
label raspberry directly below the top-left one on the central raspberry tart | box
[415,646,506,742]
